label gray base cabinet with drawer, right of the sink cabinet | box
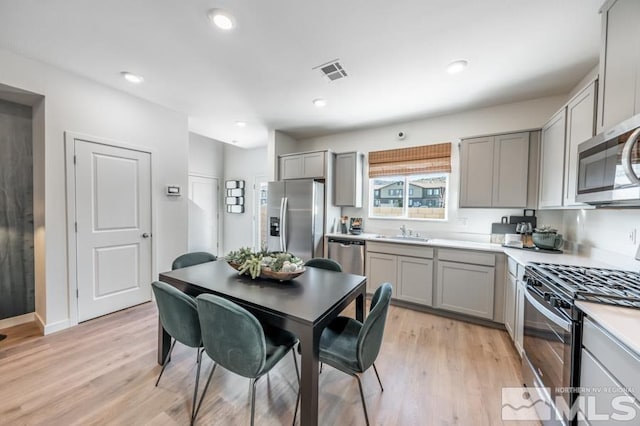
[434,249,495,320]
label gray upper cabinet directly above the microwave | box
[598,0,640,132]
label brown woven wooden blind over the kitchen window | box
[369,142,451,178]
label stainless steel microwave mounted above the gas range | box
[576,114,640,206]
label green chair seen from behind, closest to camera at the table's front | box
[193,294,299,425]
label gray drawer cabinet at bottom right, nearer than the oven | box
[580,318,640,425]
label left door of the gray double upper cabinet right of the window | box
[460,136,494,207]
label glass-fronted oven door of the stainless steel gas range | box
[523,287,573,425]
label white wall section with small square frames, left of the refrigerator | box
[222,144,270,254]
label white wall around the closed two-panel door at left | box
[0,50,188,332]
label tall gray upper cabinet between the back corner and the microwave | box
[538,80,598,209]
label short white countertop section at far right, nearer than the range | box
[576,301,640,356]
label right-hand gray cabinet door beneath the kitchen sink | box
[397,256,433,306]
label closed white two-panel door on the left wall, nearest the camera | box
[74,139,151,321]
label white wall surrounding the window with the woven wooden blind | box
[298,96,566,241]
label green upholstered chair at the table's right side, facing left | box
[294,283,392,425]
